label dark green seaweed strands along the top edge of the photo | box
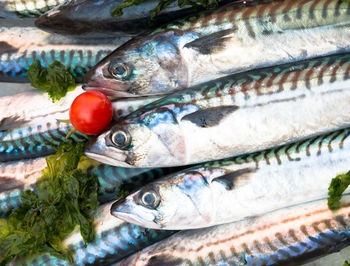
[111,0,218,19]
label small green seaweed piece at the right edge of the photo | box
[328,171,350,210]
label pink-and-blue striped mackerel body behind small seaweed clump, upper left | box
[0,22,130,82]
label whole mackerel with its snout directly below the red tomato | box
[86,54,350,167]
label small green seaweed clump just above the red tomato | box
[27,60,75,102]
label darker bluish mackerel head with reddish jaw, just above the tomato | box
[83,30,188,97]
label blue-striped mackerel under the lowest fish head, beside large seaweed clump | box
[10,204,174,266]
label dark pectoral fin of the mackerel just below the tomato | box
[181,105,239,128]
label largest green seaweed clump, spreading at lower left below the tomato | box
[0,141,99,265]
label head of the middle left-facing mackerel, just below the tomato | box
[85,107,185,167]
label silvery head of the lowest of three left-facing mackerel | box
[111,169,213,230]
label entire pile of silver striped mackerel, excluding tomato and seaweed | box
[0,0,350,266]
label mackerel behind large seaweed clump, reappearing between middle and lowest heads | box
[0,153,176,217]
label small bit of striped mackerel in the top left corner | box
[0,0,65,19]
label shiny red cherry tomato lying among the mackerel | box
[69,91,113,135]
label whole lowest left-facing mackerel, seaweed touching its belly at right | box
[111,129,350,230]
